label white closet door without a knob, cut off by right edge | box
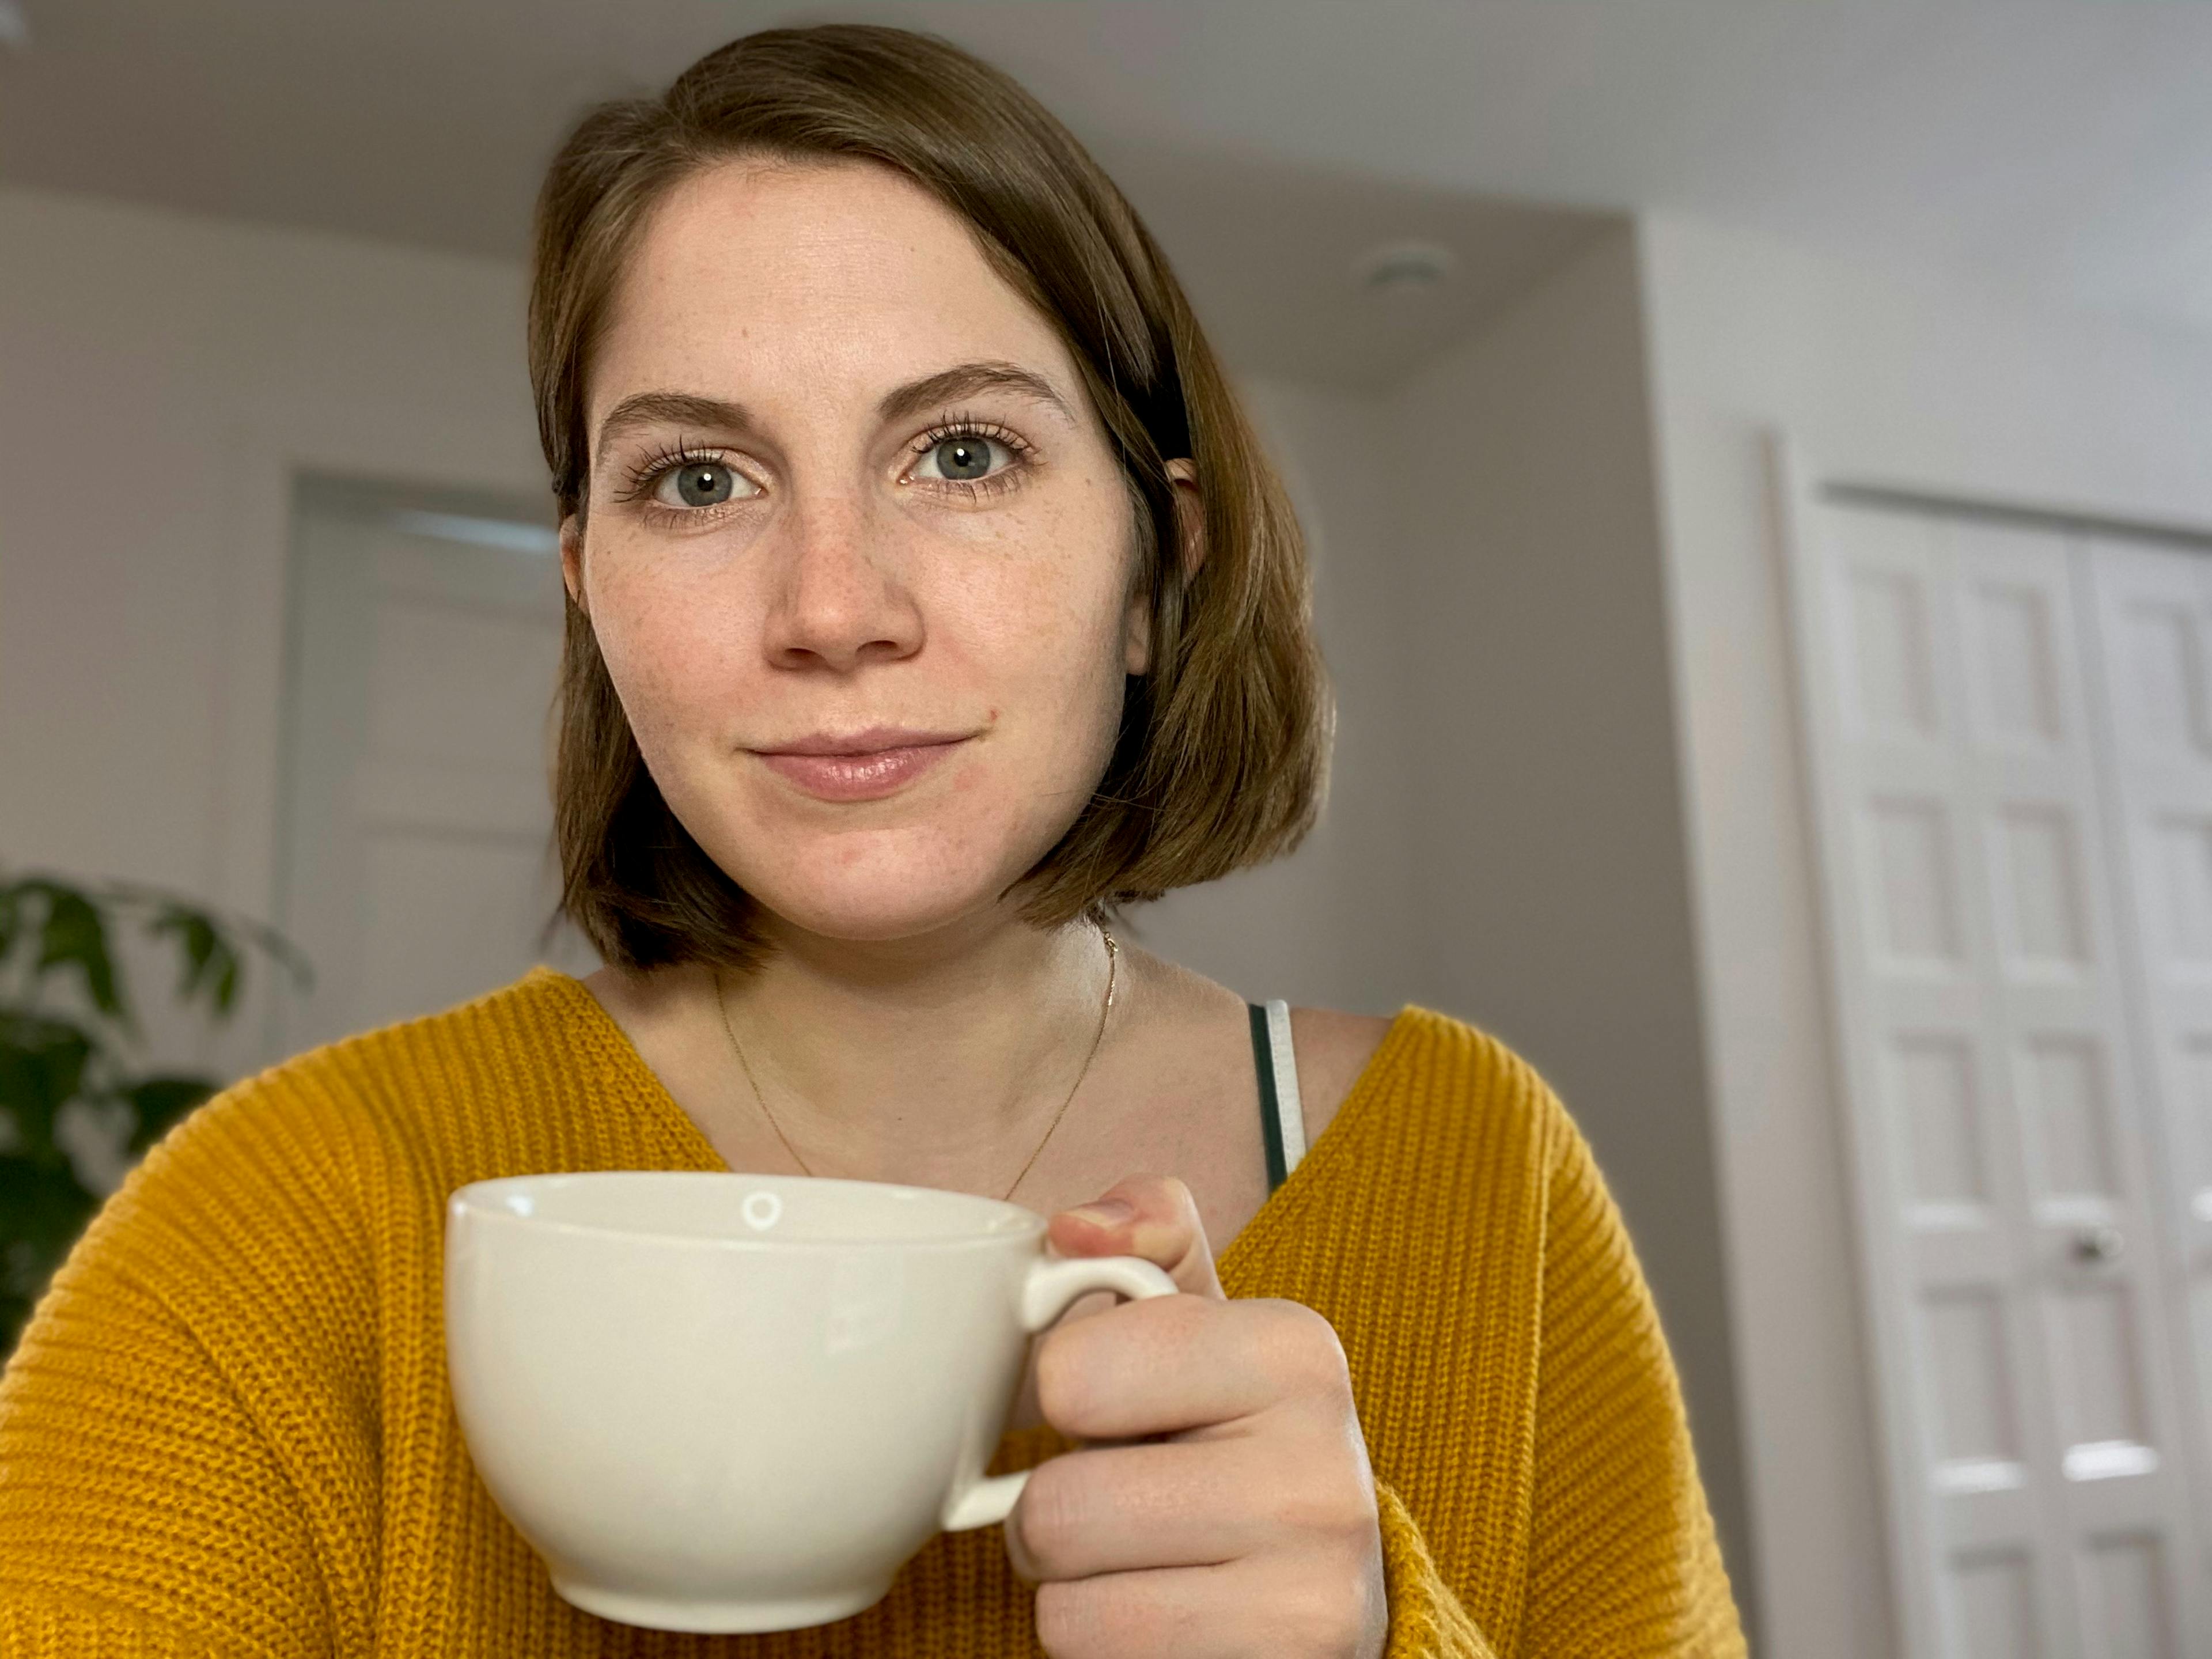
[2088,542,2212,1580]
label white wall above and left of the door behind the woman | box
[0,190,544,1070]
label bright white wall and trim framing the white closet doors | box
[1641,214,2212,1659]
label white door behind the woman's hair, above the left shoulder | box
[276,493,595,1048]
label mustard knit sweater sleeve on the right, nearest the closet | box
[1520,1101,1745,1659]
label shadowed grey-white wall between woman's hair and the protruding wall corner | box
[1393,224,1754,1601]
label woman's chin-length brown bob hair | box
[529,24,1332,969]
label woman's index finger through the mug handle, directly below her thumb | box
[1037,1296,1356,1440]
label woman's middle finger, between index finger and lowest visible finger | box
[1006,1438,1336,1584]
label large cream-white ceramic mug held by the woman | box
[445,1170,1175,1633]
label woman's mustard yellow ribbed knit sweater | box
[0,971,1743,1659]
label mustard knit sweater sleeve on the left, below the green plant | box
[0,1086,374,1659]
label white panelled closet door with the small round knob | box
[1794,502,2212,1659]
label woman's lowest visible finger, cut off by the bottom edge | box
[1037,1557,1389,1659]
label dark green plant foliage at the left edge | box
[0,876,308,1358]
